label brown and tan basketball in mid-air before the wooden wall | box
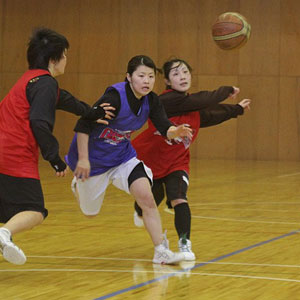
[212,12,251,50]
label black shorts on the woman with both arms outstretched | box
[152,170,189,208]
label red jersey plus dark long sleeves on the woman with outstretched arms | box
[132,86,244,179]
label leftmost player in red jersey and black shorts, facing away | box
[0,28,112,264]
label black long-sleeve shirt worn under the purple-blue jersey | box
[74,83,173,136]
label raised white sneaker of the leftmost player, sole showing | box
[0,228,26,265]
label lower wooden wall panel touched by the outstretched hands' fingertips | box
[237,76,279,160]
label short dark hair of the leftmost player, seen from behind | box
[27,27,69,70]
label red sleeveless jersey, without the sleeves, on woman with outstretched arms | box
[132,111,200,179]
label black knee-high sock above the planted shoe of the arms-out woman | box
[174,202,191,240]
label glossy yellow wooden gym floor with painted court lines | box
[0,160,300,300]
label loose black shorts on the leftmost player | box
[0,174,48,223]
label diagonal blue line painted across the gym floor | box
[94,230,300,300]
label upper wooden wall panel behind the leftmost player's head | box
[2,0,78,72]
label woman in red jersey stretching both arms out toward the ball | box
[132,58,250,261]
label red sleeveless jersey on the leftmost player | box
[0,69,50,179]
